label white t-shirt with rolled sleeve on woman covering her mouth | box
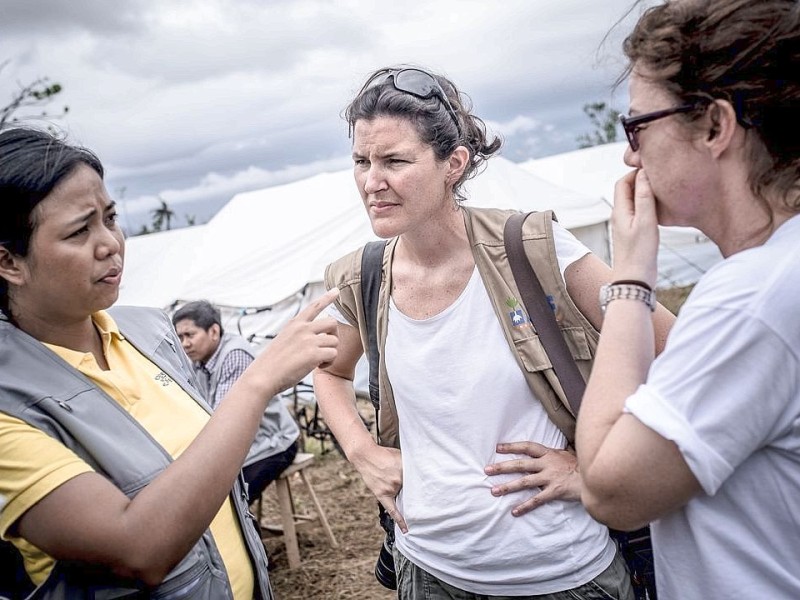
[626,217,800,600]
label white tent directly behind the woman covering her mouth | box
[520,142,722,287]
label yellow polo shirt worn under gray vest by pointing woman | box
[0,312,254,600]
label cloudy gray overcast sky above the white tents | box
[0,0,639,231]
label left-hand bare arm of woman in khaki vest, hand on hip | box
[314,323,407,531]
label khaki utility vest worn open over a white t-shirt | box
[325,207,600,447]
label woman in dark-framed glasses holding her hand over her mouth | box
[577,0,800,600]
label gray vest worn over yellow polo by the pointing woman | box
[0,307,272,600]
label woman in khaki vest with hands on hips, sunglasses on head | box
[314,67,671,600]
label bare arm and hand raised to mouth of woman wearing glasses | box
[577,172,700,529]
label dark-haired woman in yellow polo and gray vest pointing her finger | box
[0,128,337,600]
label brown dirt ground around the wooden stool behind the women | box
[262,288,691,600]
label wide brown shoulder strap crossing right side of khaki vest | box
[503,213,586,416]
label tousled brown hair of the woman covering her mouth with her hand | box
[623,0,800,211]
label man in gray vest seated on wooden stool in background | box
[172,300,300,502]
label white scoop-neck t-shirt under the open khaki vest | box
[376,223,614,595]
